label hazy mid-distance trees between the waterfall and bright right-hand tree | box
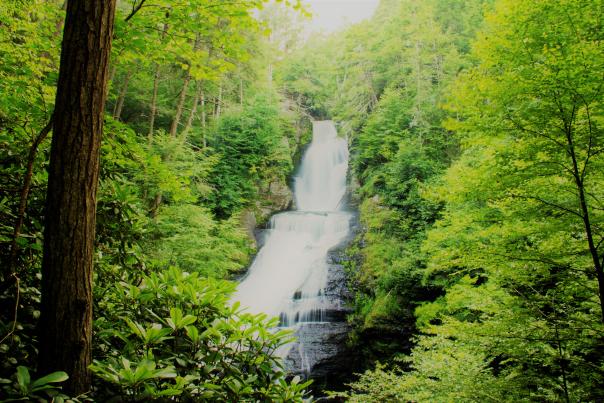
[281,0,488,361]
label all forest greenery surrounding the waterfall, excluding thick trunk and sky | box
[0,0,604,402]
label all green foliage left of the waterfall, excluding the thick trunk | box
[0,0,308,401]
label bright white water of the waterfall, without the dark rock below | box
[233,121,351,332]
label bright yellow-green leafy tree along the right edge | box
[330,0,604,401]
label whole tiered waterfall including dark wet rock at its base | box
[233,121,354,386]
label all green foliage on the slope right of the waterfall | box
[300,0,604,401]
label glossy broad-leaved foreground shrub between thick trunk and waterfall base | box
[91,268,309,402]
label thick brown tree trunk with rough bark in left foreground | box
[38,0,116,395]
